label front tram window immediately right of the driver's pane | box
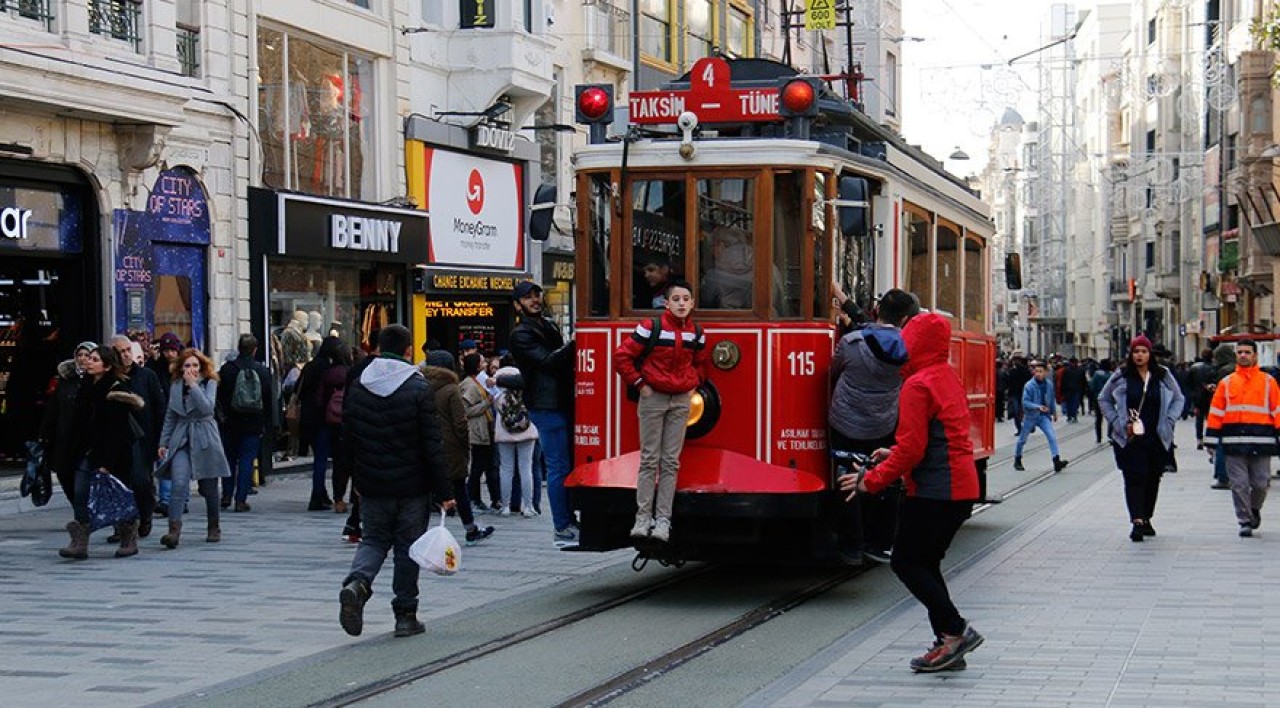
[698,179,755,310]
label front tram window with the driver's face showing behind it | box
[631,179,686,310]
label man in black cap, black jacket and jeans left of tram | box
[511,280,577,545]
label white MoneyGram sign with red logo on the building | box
[424,147,525,270]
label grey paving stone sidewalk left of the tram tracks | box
[0,475,630,708]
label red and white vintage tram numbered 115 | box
[566,58,995,562]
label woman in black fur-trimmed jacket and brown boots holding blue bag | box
[58,347,145,559]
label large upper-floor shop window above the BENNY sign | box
[257,27,376,200]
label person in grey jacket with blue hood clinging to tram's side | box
[828,288,920,563]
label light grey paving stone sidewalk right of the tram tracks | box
[749,426,1280,707]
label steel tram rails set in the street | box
[310,429,1106,708]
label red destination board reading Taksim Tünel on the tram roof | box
[628,56,781,125]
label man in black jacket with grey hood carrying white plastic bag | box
[338,324,456,636]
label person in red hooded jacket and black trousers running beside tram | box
[838,312,983,672]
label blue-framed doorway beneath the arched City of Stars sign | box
[151,243,209,350]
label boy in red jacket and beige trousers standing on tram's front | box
[613,280,710,543]
